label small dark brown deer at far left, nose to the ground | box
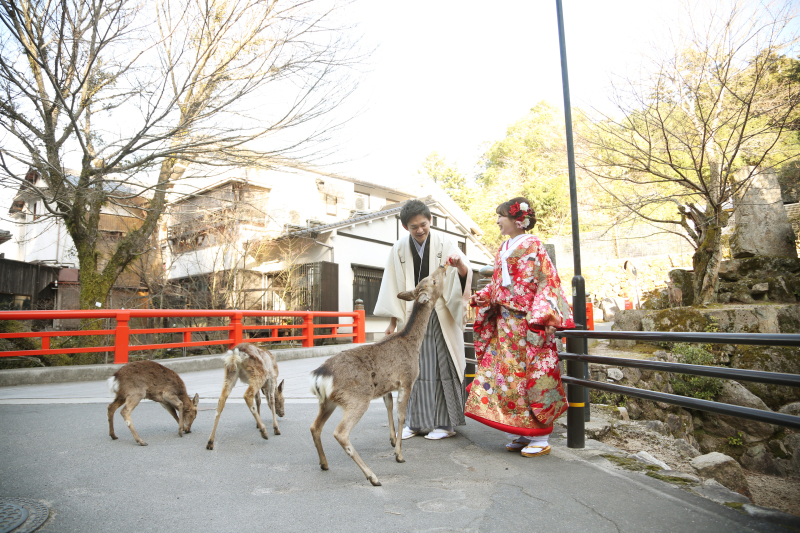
[108,361,200,446]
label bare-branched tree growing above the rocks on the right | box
[578,1,800,304]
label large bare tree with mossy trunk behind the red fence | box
[0,0,360,308]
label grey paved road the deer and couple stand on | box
[0,359,792,533]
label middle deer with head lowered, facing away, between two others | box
[206,343,285,450]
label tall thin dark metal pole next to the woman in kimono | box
[556,0,588,448]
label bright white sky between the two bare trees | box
[338,0,678,184]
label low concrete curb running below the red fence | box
[0,344,359,387]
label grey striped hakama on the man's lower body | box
[406,311,466,431]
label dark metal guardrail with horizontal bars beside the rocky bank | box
[556,330,800,448]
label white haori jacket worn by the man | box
[374,231,472,382]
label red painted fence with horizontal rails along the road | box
[0,309,366,364]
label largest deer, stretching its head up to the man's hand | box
[311,265,449,487]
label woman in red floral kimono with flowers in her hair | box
[465,197,575,457]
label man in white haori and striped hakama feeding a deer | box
[374,200,472,440]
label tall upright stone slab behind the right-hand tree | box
[730,167,797,258]
